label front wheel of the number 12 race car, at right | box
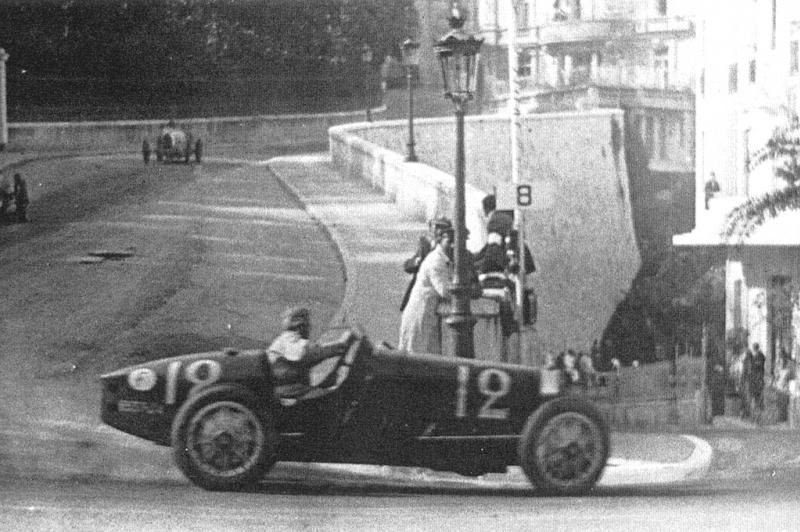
[519,397,610,495]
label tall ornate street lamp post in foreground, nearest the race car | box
[435,2,483,358]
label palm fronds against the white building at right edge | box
[725,117,800,238]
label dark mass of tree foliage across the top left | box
[0,0,417,79]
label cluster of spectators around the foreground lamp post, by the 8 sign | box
[398,194,536,354]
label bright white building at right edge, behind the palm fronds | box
[673,0,800,383]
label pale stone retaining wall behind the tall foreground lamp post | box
[330,110,640,363]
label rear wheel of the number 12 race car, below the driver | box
[172,385,278,491]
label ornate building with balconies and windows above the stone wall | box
[477,0,696,173]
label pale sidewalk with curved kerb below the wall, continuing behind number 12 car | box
[268,153,712,487]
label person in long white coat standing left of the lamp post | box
[398,224,455,354]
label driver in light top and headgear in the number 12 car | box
[267,307,346,386]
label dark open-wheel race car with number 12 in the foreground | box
[101,329,609,494]
